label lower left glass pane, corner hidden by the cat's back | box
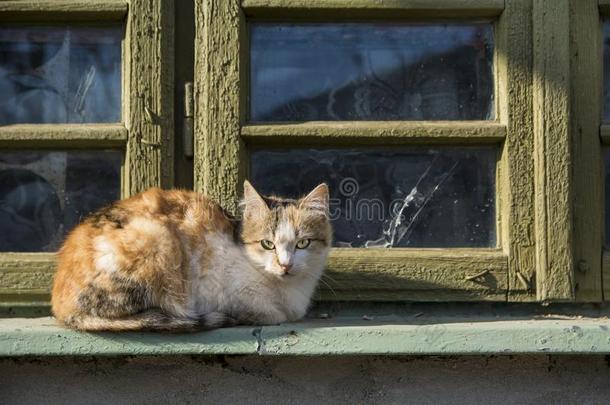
[0,151,122,252]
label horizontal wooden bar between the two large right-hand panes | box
[241,121,506,146]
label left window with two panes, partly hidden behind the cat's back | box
[0,0,173,306]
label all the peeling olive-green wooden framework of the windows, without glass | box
[0,0,610,307]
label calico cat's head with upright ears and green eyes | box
[241,181,332,279]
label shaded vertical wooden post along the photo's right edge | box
[560,0,610,302]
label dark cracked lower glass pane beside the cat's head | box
[251,148,497,247]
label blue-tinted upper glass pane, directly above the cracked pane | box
[250,23,494,122]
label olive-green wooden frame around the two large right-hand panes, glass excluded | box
[195,0,575,301]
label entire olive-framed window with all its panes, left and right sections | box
[0,0,610,305]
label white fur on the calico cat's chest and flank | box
[189,234,326,324]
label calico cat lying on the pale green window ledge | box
[51,181,332,331]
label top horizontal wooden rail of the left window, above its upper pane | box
[0,0,128,23]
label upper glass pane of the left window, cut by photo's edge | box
[0,26,122,125]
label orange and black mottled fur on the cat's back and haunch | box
[51,188,233,323]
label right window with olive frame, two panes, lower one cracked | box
[195,0,535,300]
